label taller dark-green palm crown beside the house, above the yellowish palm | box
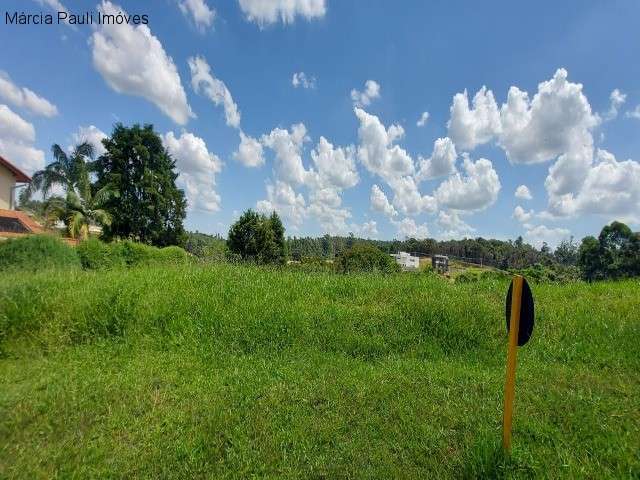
[25,142,95,199]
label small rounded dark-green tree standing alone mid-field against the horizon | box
[227,209,286,264]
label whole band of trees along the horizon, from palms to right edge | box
[20,124,640,280]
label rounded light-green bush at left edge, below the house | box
[0,235,80,271]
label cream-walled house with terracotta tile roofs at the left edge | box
[0,156,43,240]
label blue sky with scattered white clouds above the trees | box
[0,0,640,245]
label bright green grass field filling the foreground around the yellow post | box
[0,265,640,479]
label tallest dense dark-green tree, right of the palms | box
[95,124,187,246]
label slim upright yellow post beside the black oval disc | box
[502,275,523,451]
